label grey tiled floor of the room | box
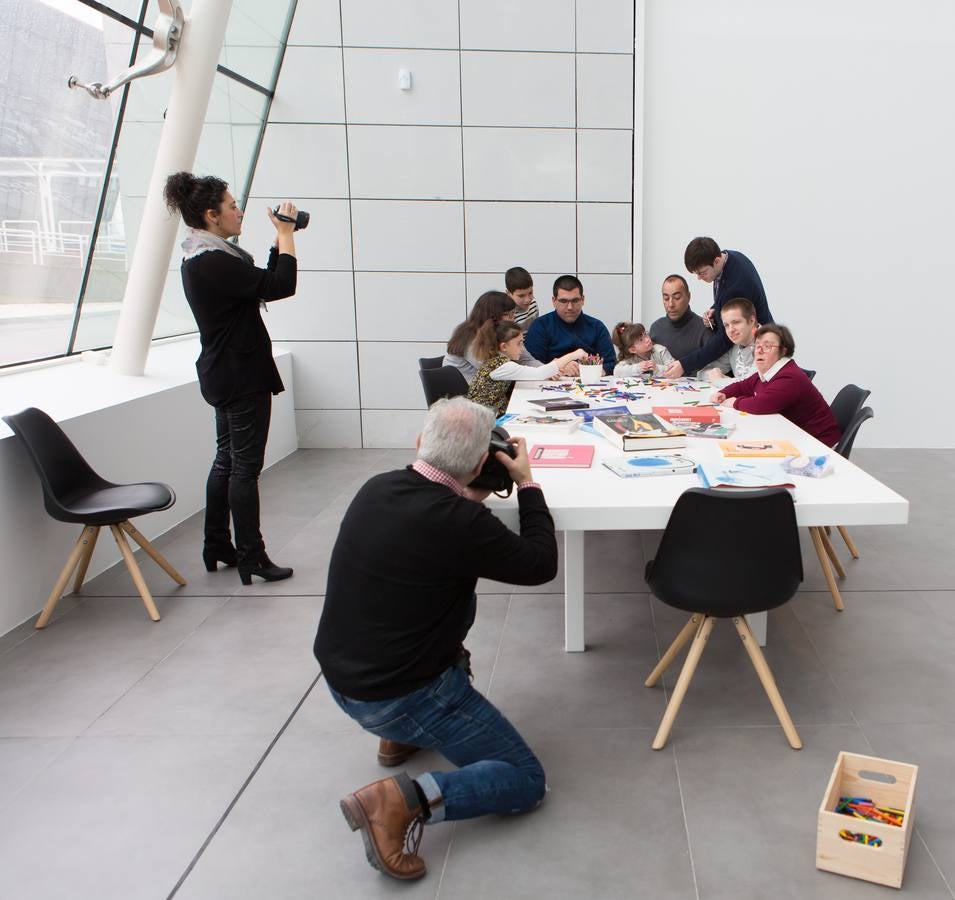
[0,450,955,900]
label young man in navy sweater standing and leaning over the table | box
[663,237,773,378]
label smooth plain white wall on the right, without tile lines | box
[635,0,955,447]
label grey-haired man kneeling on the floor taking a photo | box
[315,397,557,879]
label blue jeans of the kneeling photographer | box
[329,666,546,822]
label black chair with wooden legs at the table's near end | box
[645,488,802,750]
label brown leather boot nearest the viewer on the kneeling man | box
[340,772,427,880]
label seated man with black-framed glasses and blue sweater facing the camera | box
[524,275,617,376]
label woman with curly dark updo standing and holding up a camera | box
[164,172,298,584]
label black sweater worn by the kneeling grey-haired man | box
[315,467,557,700]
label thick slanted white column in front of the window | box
[112,0,232,375]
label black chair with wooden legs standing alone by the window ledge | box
[3,407,186,628]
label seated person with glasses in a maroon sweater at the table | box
[713,324,842,447]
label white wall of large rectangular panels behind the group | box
[254,0,634,447]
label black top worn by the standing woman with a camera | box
[182,247,297,406]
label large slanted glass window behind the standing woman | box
[0,0,289,367]
